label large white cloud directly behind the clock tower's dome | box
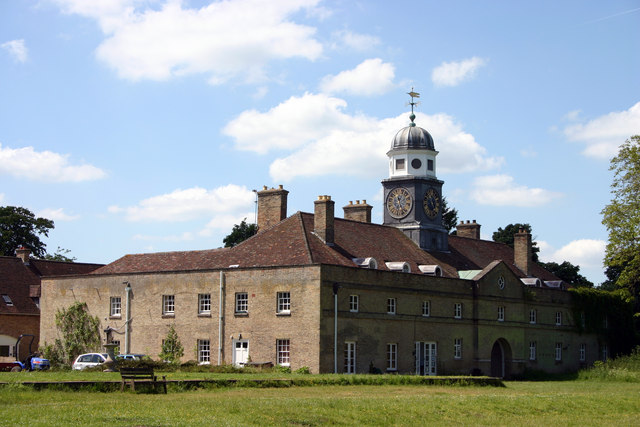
[223,93,503,181]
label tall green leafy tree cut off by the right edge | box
[601,135,640,312]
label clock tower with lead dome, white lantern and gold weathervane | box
[382,90,448,251]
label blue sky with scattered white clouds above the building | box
[0,0,640,283]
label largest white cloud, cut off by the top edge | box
[58,0,322,84]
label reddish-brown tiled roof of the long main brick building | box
[91,212,557,280]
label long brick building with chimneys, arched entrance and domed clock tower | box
[41,111,606,377]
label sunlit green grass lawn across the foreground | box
[0,380,640,426]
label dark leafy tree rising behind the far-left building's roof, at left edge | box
[0,206,53,258]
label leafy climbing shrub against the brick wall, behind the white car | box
[43,301,100,366]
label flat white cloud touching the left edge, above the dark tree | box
[0,144,106,182]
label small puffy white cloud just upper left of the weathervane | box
[320,58,395,96]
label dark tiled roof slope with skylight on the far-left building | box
[0,256,40,314]
